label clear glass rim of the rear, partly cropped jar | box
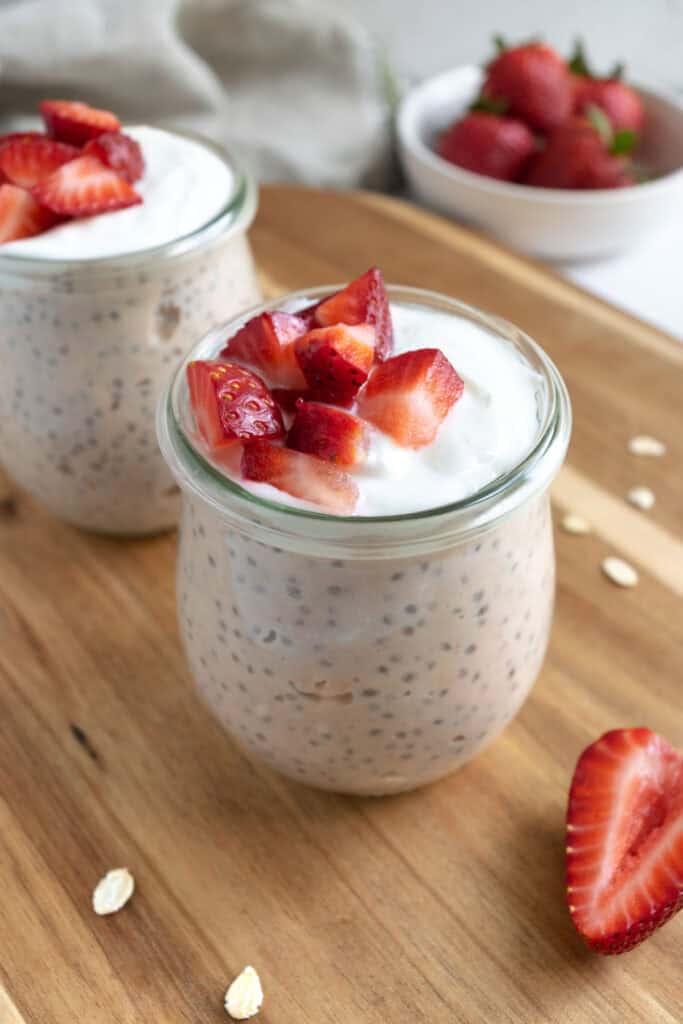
[0,125,258,276]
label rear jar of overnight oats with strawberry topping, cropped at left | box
[0,101,260,535]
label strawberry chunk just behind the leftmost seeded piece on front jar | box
[220,312,306,388]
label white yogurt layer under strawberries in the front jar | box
[216,303,544,516]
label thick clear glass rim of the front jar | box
[157,285,571,558]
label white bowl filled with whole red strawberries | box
[398,39,683,260]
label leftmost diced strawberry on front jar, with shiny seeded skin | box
[187,359,285,452]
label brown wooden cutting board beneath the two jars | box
[0,187,683,1024]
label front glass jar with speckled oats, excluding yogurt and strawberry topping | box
[158,286,571,795]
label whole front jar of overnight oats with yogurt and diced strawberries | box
[158,270,570,795]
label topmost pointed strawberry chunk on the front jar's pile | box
[299,266,393,359]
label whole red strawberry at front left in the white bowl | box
[438,111,536,181]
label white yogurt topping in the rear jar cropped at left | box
[0,125,234,260]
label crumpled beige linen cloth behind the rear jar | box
[0,0,391,187]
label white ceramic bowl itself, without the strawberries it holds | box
[398,67,683,260]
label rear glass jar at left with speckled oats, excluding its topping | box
[0,134,261,535]
